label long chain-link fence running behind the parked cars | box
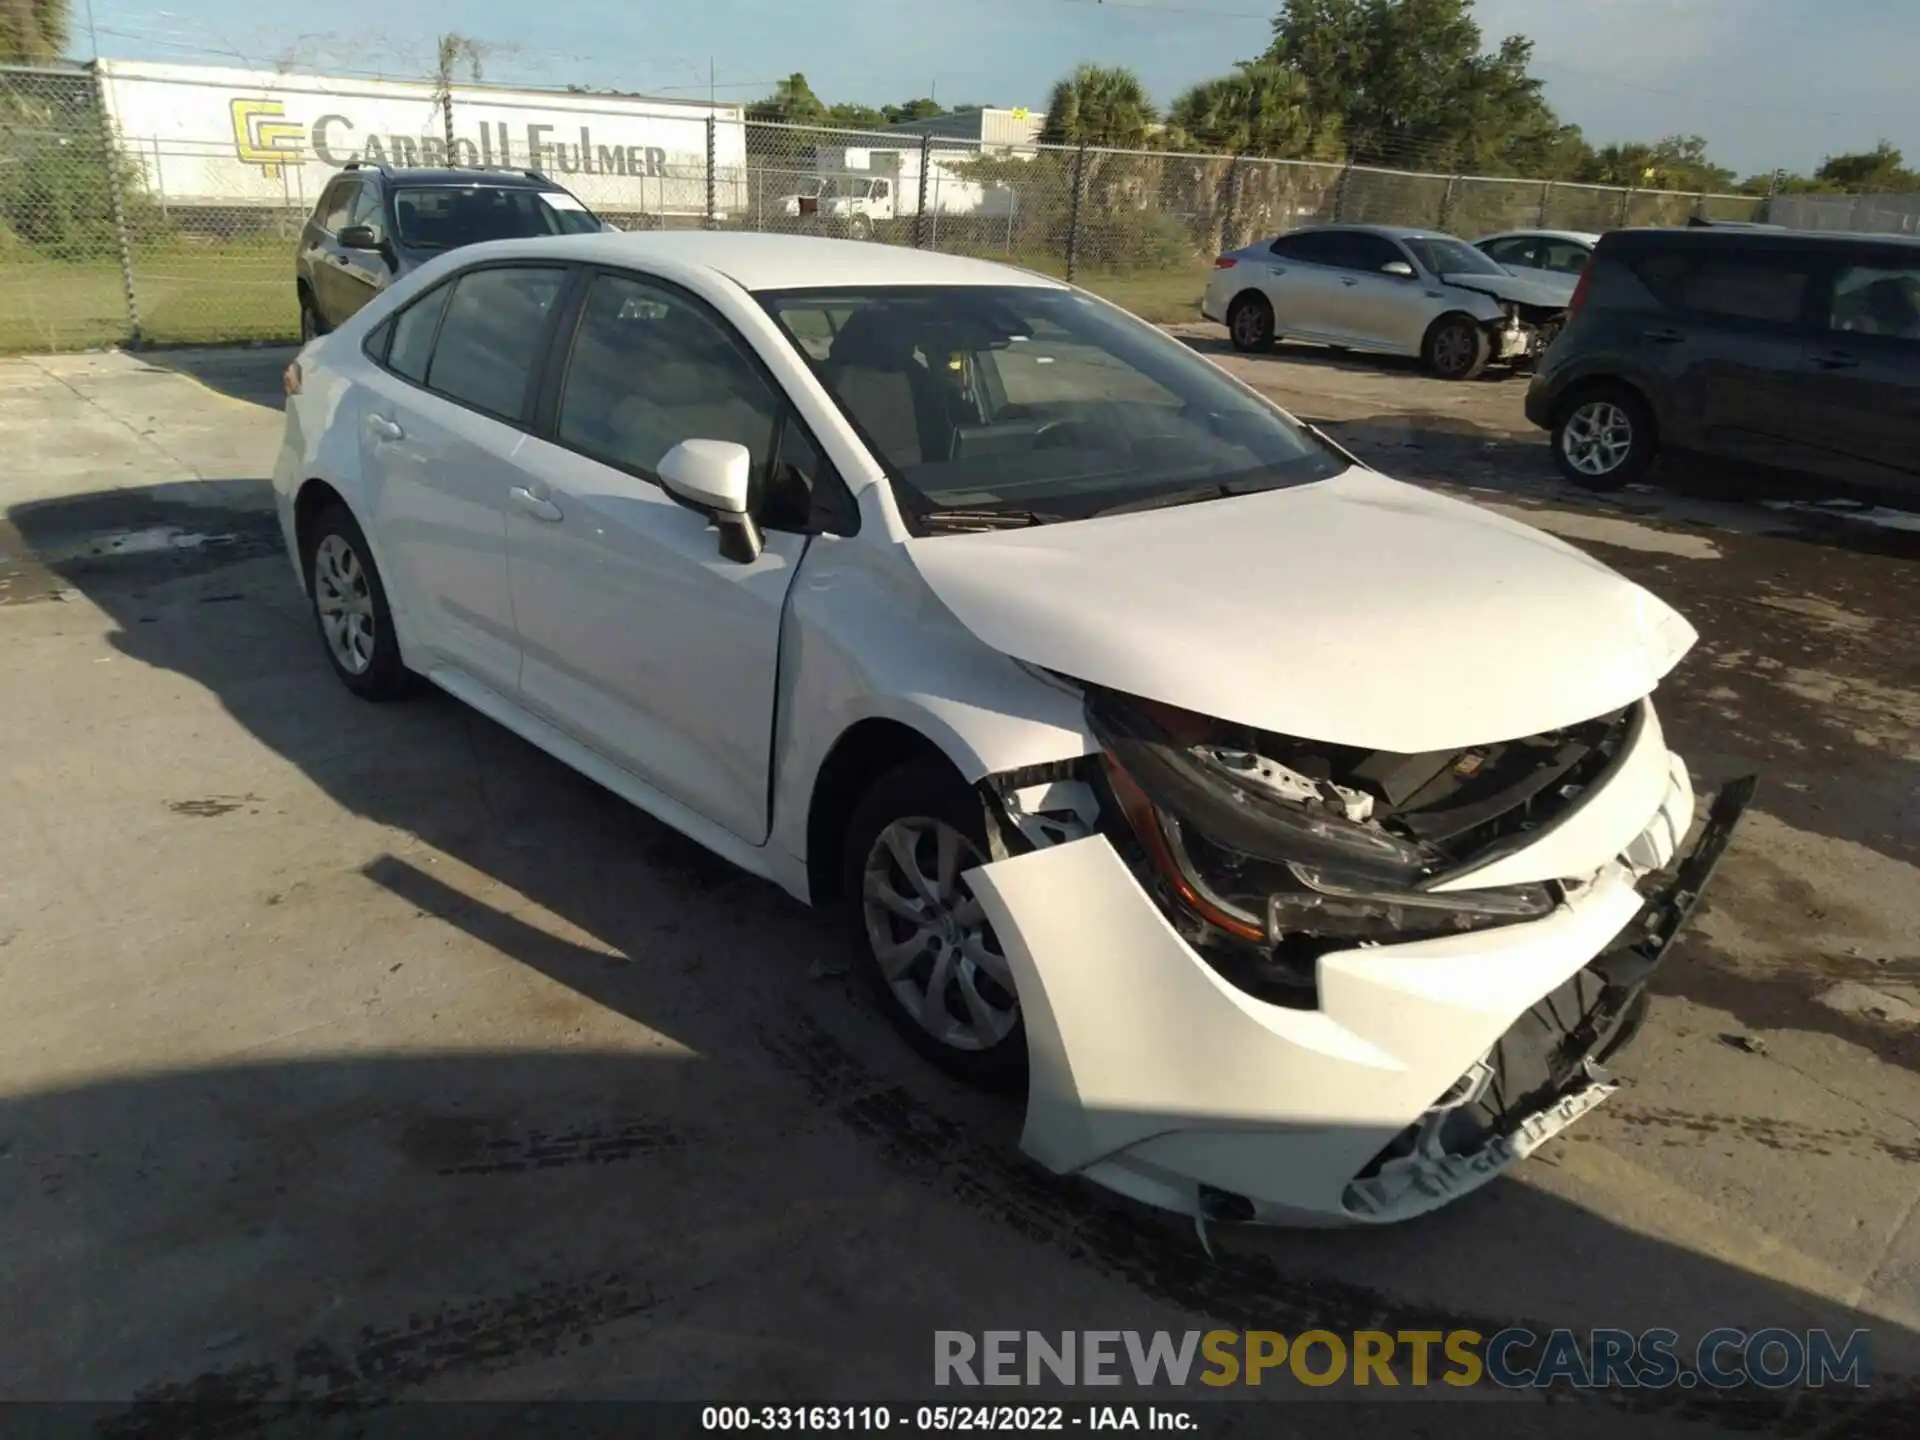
[0,67,1858,351]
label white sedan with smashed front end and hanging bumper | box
[275,232,1747,1223]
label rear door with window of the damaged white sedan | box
[361,261,568,695]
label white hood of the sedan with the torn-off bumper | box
[906,468,1697,755]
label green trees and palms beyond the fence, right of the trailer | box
[747,0,1920,194]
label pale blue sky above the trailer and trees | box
[73,0,1920,173]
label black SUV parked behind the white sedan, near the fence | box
[294,161,611,340]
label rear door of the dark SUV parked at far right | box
[1630,244,1816,468]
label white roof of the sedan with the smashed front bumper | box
[443,230,1066,290]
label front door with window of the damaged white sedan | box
[507,273,806,845]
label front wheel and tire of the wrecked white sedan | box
[841,760,1027,1089]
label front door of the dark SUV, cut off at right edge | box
[1799,253,1920,493]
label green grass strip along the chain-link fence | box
[0,236,1208,353]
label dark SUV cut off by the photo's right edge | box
[1526,227,1920,497]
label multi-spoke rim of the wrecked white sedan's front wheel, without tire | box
[860,816,1020,1050]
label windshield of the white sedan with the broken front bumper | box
[760,286,1346,520]
